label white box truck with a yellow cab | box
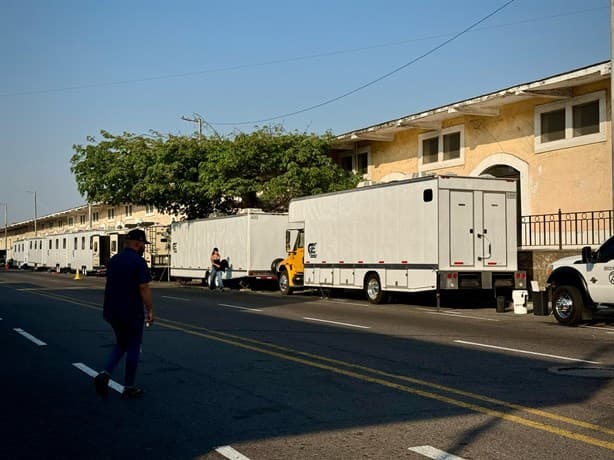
[277,176,526,303]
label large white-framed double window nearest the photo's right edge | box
[534,91,607,153]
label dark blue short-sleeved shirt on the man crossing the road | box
[103,248,151,323]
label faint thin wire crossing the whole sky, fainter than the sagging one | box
[0,6,609,97]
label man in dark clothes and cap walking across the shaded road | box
[94,229,154,398]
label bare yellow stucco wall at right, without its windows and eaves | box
[368,80,614,215]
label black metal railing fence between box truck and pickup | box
[520,209,614,249]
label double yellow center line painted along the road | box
[28,292,614,450]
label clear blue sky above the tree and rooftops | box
[0,0,610,225]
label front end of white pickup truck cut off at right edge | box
[548,236,614,326]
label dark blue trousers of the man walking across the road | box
[104,321,144,387]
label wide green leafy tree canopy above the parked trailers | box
[71,127,358,219]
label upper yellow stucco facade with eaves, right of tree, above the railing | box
[334,62,614,223]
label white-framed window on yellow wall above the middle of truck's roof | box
[418,126,464,170]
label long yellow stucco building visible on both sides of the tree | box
[0,61,614,264]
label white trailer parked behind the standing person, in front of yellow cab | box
[170,209,288,282]
